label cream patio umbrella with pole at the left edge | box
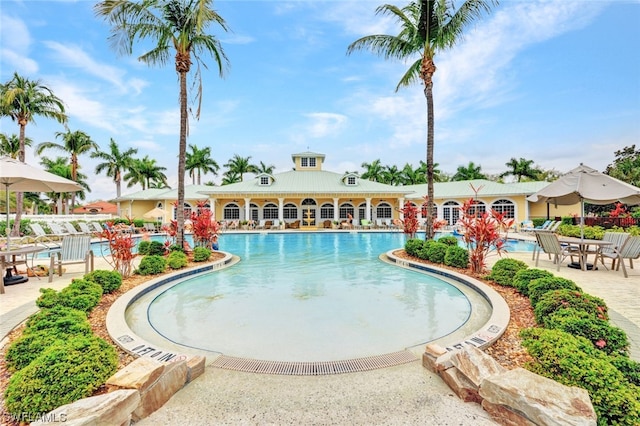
[0,156,82,248]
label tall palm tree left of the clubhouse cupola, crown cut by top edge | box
[94,0,228,247]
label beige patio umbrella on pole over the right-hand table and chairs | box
[527,163,640,238]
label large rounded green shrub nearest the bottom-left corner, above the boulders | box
[5,336,118,416]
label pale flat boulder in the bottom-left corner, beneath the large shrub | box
[31,389,140,426]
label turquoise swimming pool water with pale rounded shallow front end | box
[127,232,487,361]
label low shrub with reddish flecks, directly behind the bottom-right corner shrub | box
[544,309,629,354]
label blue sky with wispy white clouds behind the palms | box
[0,0,640,200]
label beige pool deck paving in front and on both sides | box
[0,231,640,425]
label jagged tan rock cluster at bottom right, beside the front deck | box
[422,345,597,426]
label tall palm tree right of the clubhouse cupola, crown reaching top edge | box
[347,0,497,239]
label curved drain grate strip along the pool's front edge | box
[211,351,418,376]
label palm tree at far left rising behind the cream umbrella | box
[0,72,67,236]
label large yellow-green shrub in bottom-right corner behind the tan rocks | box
[520,328,640,425]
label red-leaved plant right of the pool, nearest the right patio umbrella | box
[458,198,513,274]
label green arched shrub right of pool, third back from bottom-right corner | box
[533,290,609,324]
